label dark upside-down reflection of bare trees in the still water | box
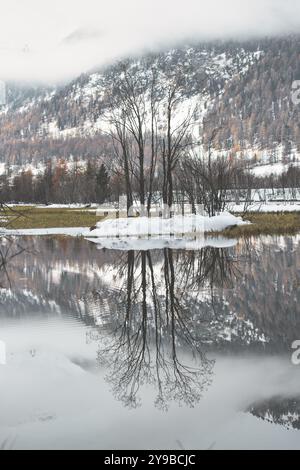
[98,244,241,410]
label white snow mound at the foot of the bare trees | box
[90,212,249,238]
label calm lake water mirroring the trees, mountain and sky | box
[0,237,300,449]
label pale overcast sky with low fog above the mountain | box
[0,0,300,82]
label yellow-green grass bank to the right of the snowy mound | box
[222,212,300,238]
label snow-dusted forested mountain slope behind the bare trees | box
[0,37,300,173]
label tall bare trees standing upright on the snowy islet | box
[107,62,193,212]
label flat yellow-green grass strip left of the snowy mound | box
[1,206,101,229]
